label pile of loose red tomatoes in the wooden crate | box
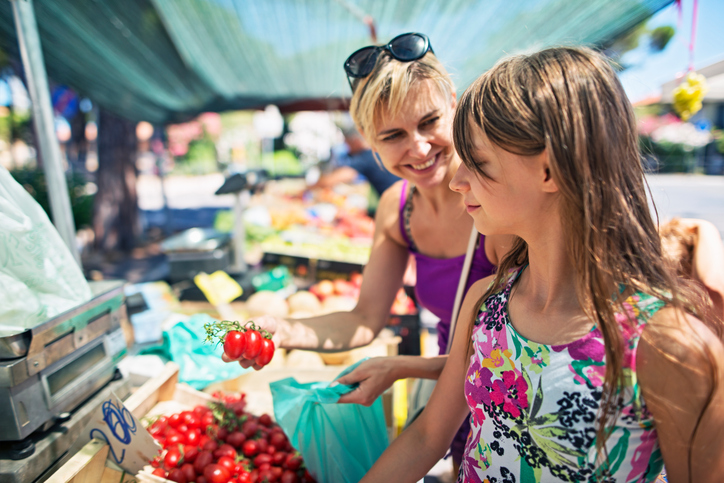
[148,394,314,483]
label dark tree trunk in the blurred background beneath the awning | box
[93,109,141,252]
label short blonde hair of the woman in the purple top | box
[349,51,455,137]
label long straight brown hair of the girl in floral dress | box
[453,47,722,478]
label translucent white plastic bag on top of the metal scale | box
[0,166,92,336]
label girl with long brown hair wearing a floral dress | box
[363,48,724,483]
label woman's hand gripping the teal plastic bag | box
[332,357,399,406]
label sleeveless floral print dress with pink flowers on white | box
[458,269,664,483]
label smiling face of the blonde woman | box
[370,81,455,188]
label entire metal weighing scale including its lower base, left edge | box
[0,281,130,483]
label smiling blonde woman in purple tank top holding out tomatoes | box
[224,33,509,462]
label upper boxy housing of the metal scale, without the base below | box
[0,281,126,442]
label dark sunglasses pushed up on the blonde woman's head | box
[344,32,435,92]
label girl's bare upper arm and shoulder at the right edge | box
[636,308,724,483]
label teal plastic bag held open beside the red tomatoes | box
[269,361,389,483]
